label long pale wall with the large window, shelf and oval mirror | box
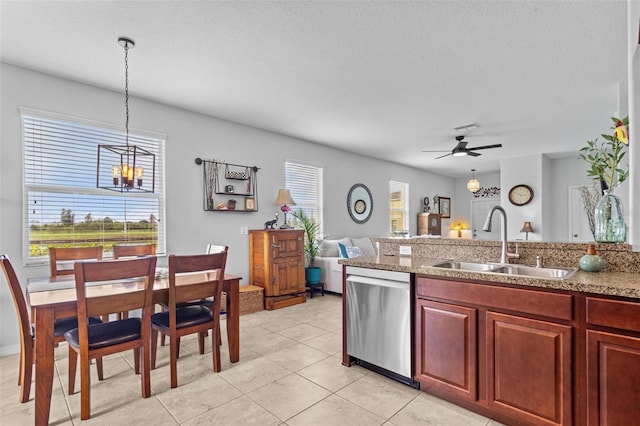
[0,64,455,355]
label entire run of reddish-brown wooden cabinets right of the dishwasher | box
[415,275,640,426]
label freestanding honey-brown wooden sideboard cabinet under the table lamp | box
[249,229,307,310]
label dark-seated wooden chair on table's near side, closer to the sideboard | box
[151,250,227,388]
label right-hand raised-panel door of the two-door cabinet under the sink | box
[487,312,572,425]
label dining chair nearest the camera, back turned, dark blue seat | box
[64,256,157,420]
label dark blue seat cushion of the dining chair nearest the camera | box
[64,318,142,349]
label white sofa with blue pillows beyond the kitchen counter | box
[313,237,377,294]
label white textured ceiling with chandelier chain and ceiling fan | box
[0,0,627,176]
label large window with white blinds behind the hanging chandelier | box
[21,108,166,263]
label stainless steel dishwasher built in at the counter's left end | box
[346,266,418,388]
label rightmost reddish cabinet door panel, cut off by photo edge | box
[587,330,640,426]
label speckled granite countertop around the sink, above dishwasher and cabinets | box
[339,255,640,299]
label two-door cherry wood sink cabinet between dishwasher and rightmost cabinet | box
[415,276,574,425]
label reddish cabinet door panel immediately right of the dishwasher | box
[416,299,477,401]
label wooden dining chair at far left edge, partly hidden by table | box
[0,254,104,402]
